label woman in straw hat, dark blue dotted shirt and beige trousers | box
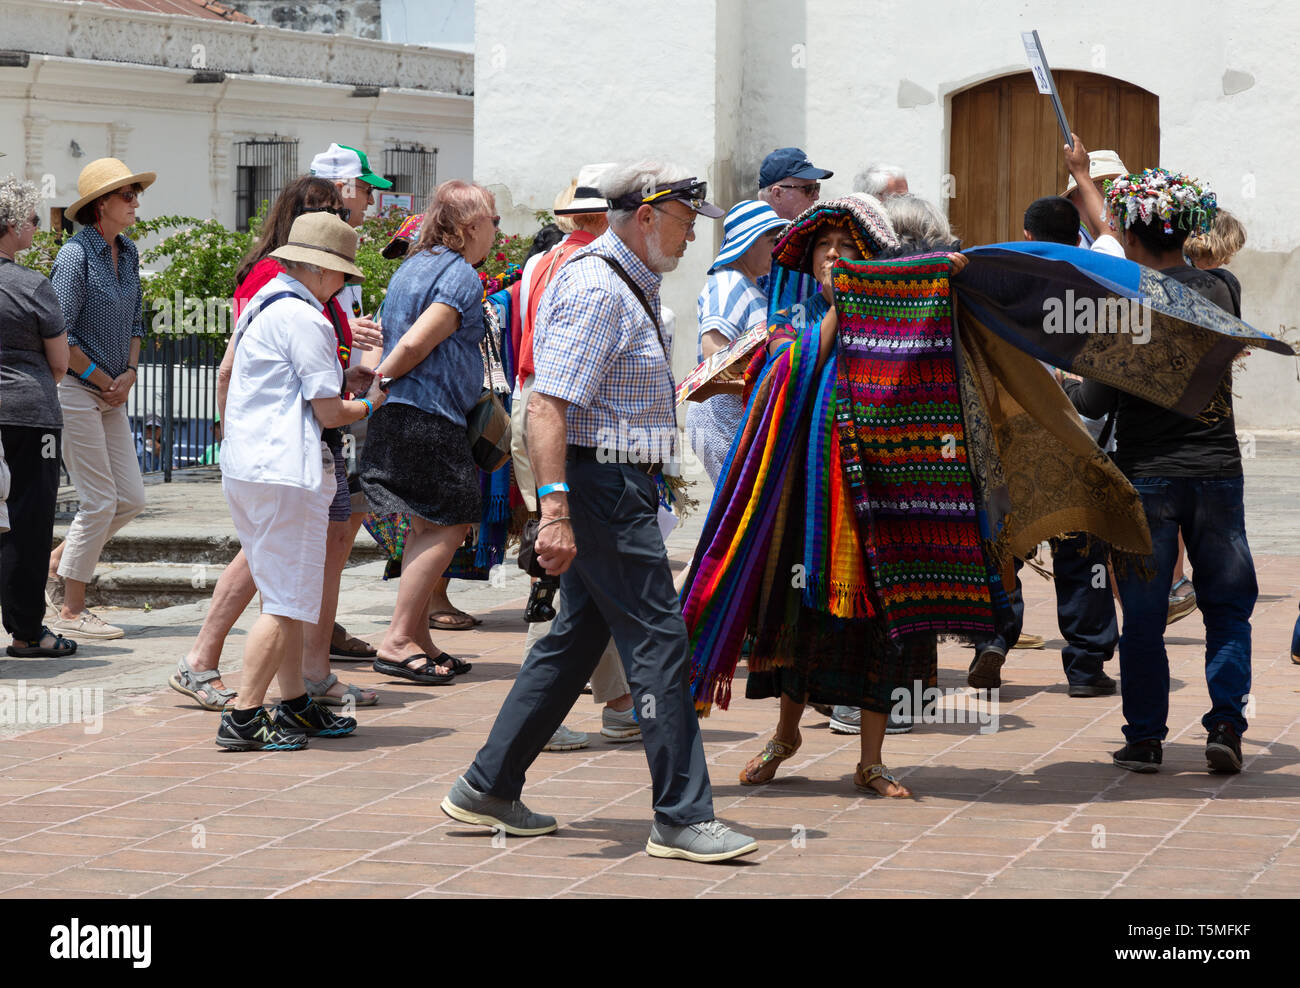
[49,157,156,641]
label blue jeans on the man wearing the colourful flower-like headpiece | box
[1117,477,1260,742]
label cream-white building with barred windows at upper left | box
[0,0,473,235]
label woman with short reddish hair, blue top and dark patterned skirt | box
[359,179,501,684]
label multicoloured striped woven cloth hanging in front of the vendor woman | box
[826,254,993,641]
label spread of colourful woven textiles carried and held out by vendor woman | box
[683,243,1292,714]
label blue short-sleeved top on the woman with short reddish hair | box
[382,247,484,425]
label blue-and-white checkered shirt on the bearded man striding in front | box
[533,230,677,463]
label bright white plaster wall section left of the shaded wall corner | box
[475,0,740,378]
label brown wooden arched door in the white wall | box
[948,72,1160,247]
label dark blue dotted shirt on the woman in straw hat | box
[49,226,144,390]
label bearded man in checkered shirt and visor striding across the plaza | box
[442,161,758,862]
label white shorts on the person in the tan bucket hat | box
[221,476,334,624]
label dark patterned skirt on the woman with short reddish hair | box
[358,402,482,525]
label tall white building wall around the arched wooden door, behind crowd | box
[475,0,1300,430]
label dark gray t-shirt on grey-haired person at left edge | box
[0,257,64,429]
